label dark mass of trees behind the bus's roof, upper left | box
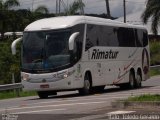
[0,0,51,40]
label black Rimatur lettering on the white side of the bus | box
[91,49,119,59]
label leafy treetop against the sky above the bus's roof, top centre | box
[65,0,85,15]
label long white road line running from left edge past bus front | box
[0,101,107,111]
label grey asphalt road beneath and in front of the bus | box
[0,76,160,120]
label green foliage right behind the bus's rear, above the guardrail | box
[150,41,160,65]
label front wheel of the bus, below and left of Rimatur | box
[79,74,92,95]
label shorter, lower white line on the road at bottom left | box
[11,109,67,115]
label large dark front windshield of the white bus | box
[22,29,71,71]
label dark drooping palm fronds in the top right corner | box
[141,0,160,35]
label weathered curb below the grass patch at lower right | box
[111,100,160,109]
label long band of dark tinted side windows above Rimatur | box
[86,25,148,50]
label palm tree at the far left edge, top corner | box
[0,0,20,39]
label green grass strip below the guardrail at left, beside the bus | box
[0,91,36,100]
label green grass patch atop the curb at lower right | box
[126,94,160,102]
